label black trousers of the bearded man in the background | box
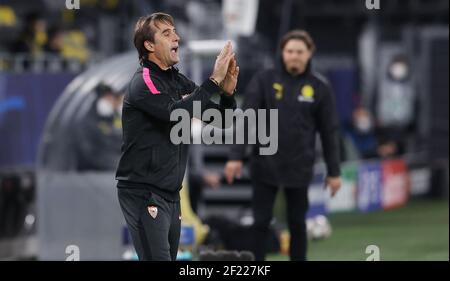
[252,181,309,261]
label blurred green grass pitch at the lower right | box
[268,199,449,261]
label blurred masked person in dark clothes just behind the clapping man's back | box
[75,84,123,171]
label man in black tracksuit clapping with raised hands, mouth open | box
[116,13,239,260]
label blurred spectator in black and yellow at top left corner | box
[11,12,47,56]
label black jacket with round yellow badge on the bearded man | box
[229,65,340,187]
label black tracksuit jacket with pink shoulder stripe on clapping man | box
[116,60,236,201]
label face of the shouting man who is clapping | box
[146,22,180,69]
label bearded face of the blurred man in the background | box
[282,39,312,75]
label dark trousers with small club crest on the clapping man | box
[118,188,181,261]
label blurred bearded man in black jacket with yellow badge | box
[225,30,341,260]
